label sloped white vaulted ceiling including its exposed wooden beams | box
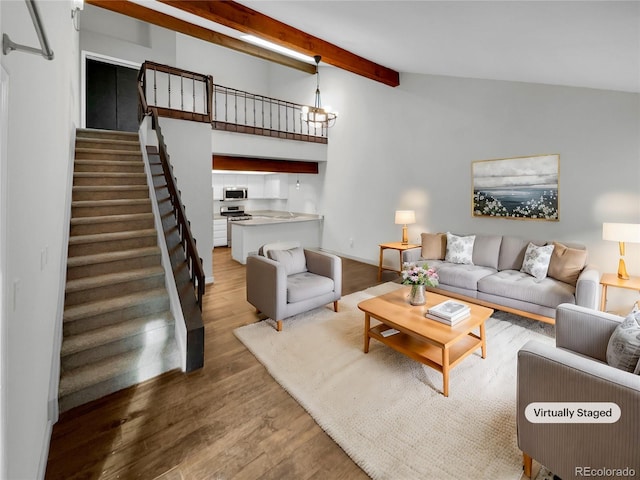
[87,0,640,92]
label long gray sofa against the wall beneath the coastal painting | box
[403,233,600,323]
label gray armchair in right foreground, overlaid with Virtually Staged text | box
[517,304,640,480]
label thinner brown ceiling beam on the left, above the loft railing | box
[86,0,316,74]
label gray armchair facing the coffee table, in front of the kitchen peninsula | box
[246,248,342,331]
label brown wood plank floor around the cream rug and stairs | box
[46,248,384,480]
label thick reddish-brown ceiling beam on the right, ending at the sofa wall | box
[159,0,400,87]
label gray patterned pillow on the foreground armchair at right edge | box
[607,310,640,374]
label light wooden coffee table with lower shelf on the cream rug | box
[358,287,493,397]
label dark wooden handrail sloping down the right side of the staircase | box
[138,65,205,310]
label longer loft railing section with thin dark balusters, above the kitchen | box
[212,85,327,143]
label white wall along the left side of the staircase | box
[0,1,78,479]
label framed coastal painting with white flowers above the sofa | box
[471,154,560,222]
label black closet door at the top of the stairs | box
[86,59,138,132]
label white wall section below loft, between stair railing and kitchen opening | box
[160,118,213,282]
